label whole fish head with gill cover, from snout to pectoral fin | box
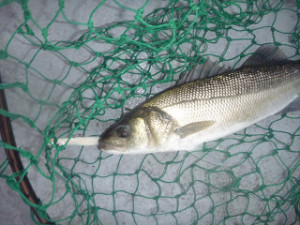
[98,107,177,154]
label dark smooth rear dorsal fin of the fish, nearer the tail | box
[243,45,288,66]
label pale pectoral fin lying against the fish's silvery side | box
[175,120,215,138]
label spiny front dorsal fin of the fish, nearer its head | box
[176,58,230,85]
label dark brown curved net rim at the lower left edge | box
[0,74,54,224]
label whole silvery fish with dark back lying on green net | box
[98,45,300,154]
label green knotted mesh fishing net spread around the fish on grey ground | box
[0,0,300,225]
